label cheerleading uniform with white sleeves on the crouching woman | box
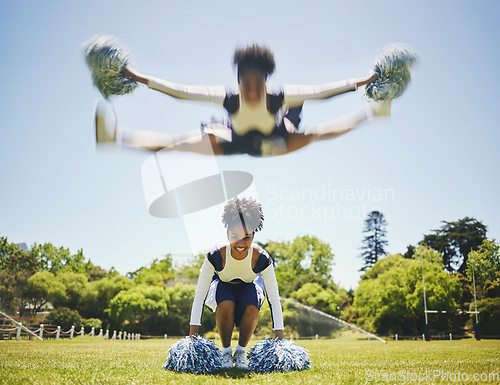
[190,244,283,330]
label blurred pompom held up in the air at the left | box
[83,35,137,99]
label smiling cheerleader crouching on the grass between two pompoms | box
[189,198,283,369]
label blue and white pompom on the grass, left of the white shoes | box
[163,337,222,374]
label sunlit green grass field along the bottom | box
[0,338,500,385]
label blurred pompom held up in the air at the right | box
[365,44,417,101]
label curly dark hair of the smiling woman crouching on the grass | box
[222,198,264,234]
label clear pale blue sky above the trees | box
[0,0,500,288]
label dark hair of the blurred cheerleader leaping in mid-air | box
[233,44,276,80]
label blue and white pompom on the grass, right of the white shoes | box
[248,339,311,373]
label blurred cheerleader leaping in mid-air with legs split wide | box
[89,44,409,156]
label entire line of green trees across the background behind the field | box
[0,212,500,336]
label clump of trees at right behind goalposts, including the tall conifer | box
[354,211,500,336]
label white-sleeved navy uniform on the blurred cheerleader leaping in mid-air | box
[148,77,357,156]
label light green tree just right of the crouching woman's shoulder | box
[262,236,334,297]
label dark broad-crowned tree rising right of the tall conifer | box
[421,217,487,275]
